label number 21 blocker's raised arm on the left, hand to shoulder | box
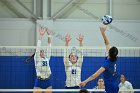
[64,34,71,68]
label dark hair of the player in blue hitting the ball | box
[109,46,118,62]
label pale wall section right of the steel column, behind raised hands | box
[37,20,140,47]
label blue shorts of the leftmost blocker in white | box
[34,79,52,89]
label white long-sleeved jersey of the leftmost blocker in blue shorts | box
[34,40,51,78]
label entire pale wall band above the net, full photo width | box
[0,19,140,47]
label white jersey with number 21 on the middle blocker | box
[64,47,83,87]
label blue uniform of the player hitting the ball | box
[102,59,119,93]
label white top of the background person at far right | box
[119,81,134,93]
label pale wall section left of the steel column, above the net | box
[0,19,36,46]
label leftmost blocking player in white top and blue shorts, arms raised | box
[34,27,52,93]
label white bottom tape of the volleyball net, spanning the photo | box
[0,89,140,93]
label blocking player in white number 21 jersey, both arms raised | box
[64,34,84,93]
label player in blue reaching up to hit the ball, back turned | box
[80,25,119,93]
